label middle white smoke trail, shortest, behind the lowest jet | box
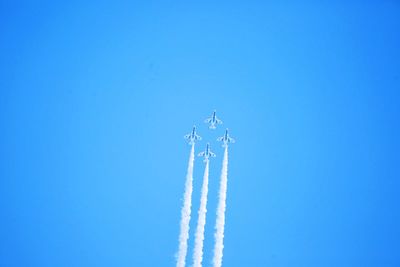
[193,160,209,267]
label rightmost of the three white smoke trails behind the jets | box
[213,146,228,267]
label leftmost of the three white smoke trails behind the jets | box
[176,144,194,267]
